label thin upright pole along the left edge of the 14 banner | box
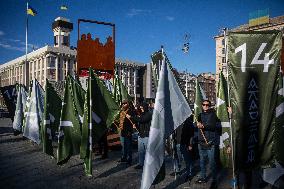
[223,28,236,189]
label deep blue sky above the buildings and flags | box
[0,0,284,74]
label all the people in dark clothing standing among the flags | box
[93,100,270,188]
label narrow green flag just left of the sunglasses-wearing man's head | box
[194,78,206,121]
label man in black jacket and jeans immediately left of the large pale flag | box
[127,102,152,169]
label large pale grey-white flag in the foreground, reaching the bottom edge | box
[141,49,191,189]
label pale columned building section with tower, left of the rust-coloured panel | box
[0,17,77,86]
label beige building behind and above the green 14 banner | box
[214,15,284,82]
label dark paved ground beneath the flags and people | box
[0,119,268,189]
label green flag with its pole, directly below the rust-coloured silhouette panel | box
[80,69,119,175]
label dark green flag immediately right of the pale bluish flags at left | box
[41,79,62,156]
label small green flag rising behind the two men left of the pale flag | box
[113,75,131,105]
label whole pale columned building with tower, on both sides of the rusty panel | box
[0,17,147,101]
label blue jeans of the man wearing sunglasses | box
[198,144,217,181]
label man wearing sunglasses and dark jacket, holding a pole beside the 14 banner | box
[197,100,220,188]
